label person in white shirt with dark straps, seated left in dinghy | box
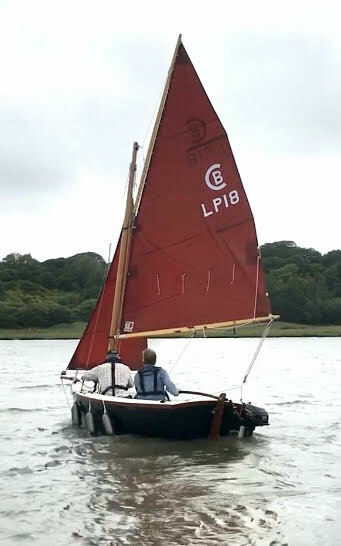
[82,351,134,397]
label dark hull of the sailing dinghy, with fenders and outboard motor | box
[75,393,268,440]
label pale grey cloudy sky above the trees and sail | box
[0,0,341,260]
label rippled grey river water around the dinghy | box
[0,338,341,546]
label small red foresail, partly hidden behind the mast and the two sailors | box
[68,240,147,370]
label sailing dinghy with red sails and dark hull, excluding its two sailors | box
[61,36,273,439]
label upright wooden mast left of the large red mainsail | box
[108,142,139,350]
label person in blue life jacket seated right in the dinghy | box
[134,349,179,400]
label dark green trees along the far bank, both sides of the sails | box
[0,241,341,328]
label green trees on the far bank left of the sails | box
[0,252,106,328]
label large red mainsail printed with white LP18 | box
[121,44,270,334]
